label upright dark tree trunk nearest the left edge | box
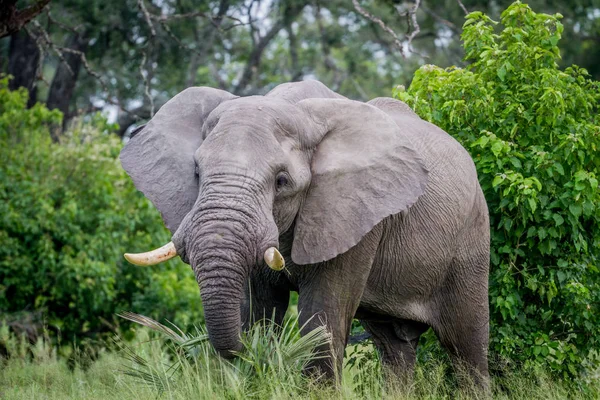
[8,30,40,108]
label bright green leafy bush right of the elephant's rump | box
[395,2,600,374]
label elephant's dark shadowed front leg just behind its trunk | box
[241,274,290,331]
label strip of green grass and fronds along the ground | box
[0,314,600,400]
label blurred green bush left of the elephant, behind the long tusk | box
[0,78,202,341]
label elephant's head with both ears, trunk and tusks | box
[121,81,427,356]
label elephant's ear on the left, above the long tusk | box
[120,87,236,233]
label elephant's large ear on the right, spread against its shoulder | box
[292,99,428,264]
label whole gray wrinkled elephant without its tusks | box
[121,81,489,386]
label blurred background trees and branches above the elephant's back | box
[0,0,600,135]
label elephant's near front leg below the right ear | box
[296,227,381,382]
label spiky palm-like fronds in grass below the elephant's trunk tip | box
[114,313,329,399]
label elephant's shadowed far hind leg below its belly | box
[361,320,428,381]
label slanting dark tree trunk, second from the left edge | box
[46,34,88,134]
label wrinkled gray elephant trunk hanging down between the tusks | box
[185,189,274,358]
